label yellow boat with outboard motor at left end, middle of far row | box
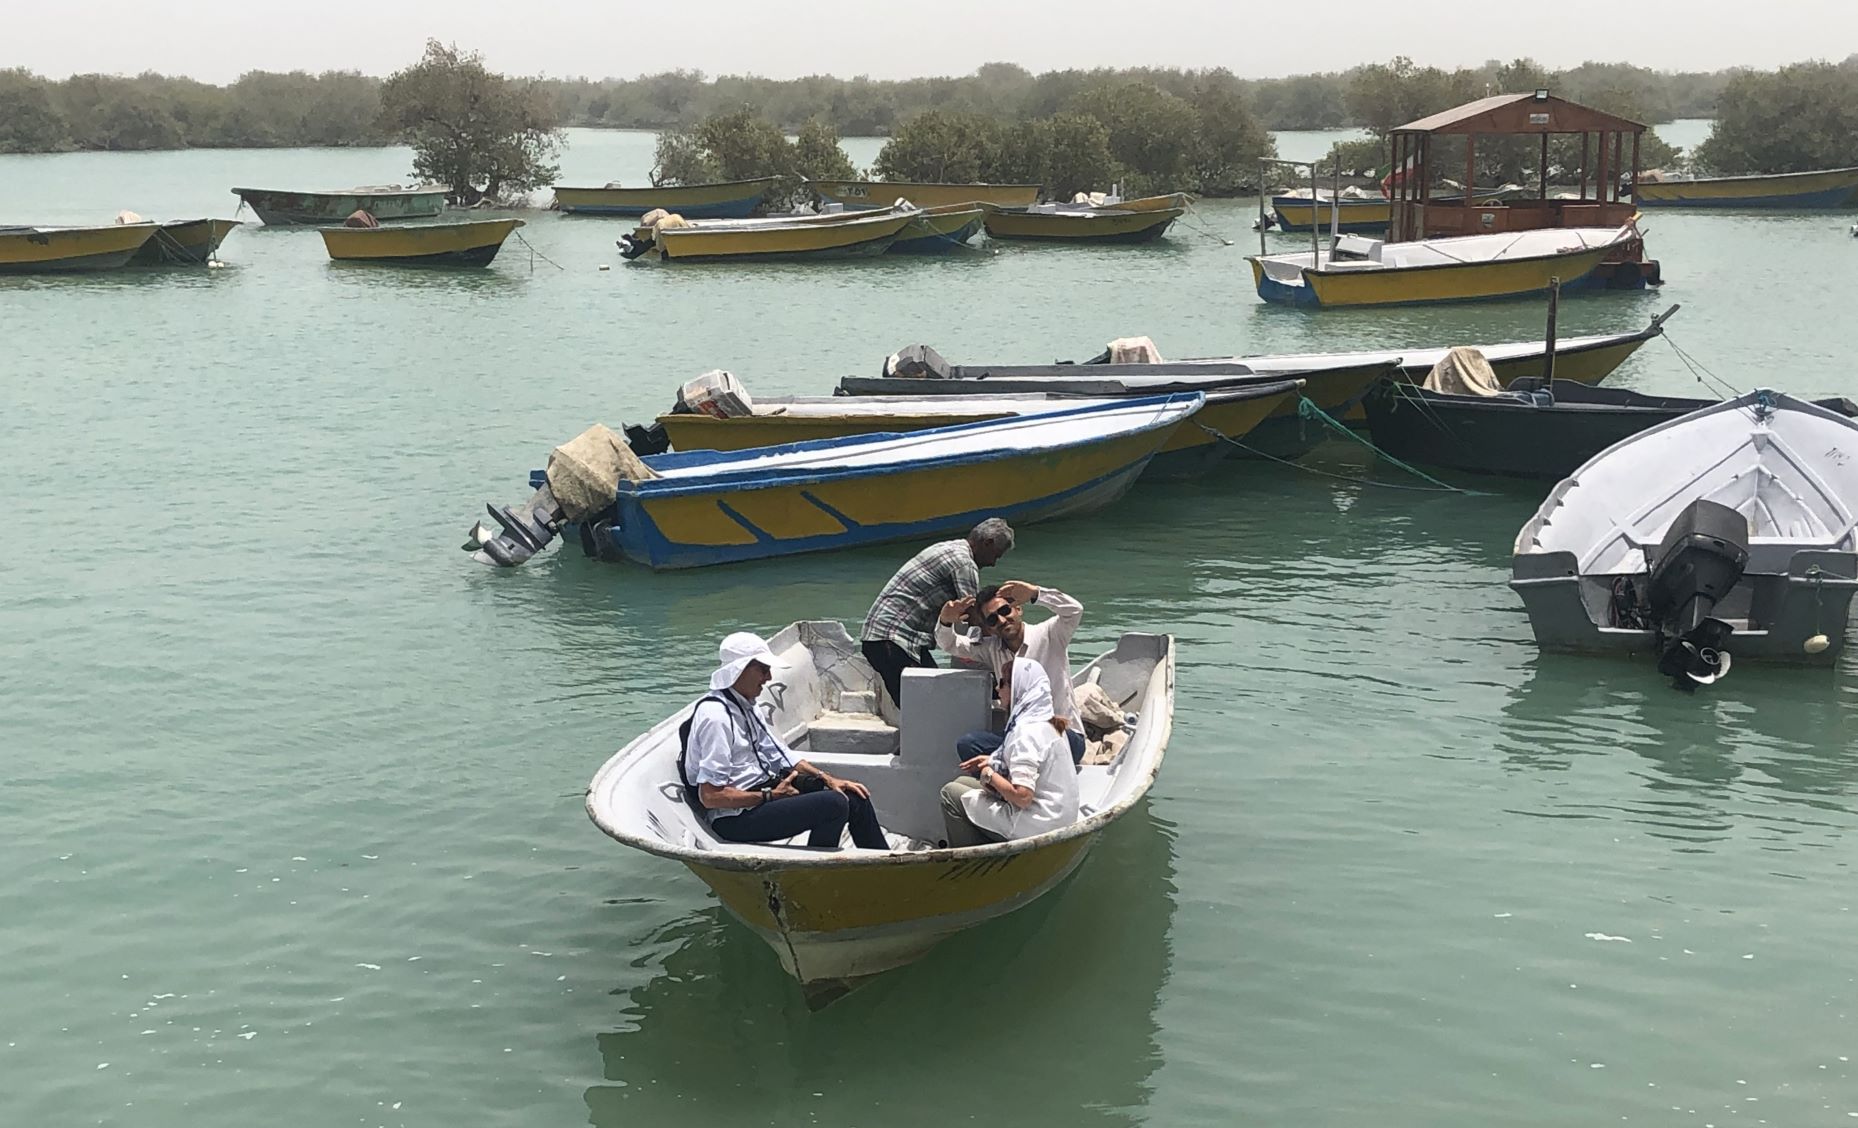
[619,208,918,262]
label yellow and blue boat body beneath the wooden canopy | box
[1249,223,1642,308]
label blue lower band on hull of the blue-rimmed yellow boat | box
[608,457,1148,571]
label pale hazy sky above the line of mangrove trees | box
[14,0,1858,82]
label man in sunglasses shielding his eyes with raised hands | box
[935,580,1083,764]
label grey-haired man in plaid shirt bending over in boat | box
[860,517,1013,702]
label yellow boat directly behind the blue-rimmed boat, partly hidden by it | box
[656,379,1300,481]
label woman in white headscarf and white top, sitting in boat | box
[942,658,1078,846]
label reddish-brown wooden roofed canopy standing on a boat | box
[1388,89,1655,243]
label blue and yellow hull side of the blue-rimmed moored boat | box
[606,429,1169,571]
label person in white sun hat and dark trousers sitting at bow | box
[678,630,890,849]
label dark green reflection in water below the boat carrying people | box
[585,803,1176,1128]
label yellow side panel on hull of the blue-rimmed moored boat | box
[641,425,1159,548]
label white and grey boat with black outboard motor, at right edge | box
[1511,390,1858,686]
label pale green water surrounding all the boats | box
[0,134,1858,1128]
